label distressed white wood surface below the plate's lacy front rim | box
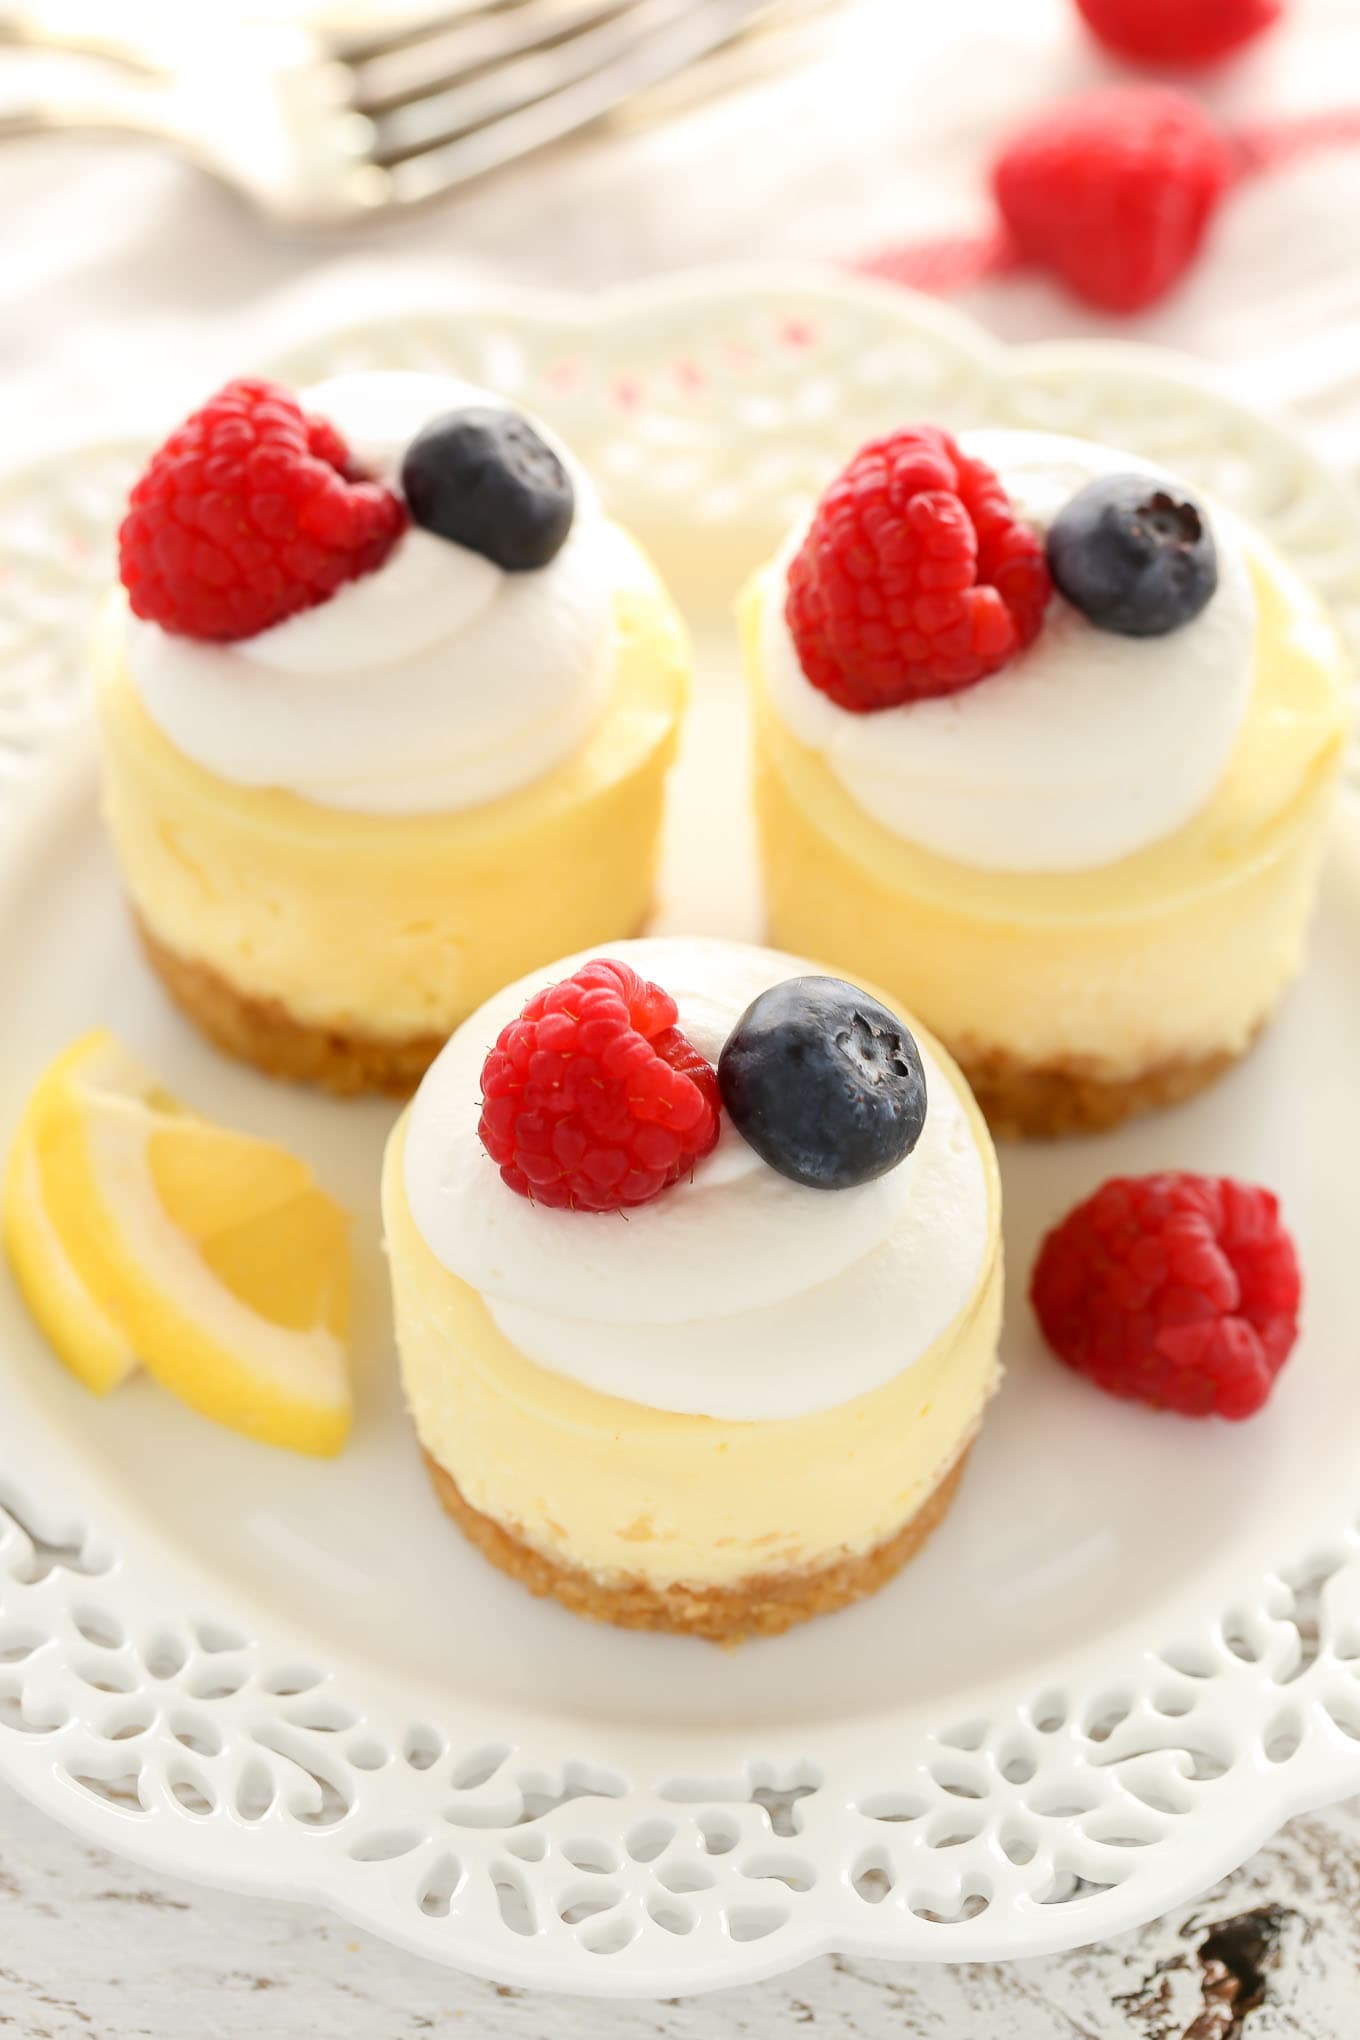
[0,1789,1360,2040]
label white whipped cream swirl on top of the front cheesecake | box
[406,938,991,1422]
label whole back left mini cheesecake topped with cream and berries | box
[96,373,687,1093]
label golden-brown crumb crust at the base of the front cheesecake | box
[424,1446,971,1644]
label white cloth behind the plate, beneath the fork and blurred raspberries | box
[0,0,1360,465]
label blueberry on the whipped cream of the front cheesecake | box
[718,977,926,1189]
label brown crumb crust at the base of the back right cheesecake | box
[952,1022,1264,1140]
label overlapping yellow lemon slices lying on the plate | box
[4,1028,351,1455]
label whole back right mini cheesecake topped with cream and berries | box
[742,428,1352,1134]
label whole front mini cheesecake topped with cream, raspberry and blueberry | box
[383,940,1001,1640]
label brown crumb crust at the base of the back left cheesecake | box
[133,914,444,1098]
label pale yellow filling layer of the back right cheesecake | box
[742,539,1352,1077]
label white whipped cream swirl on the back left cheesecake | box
[126,371,623,814]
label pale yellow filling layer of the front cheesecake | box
[383,1036,1001,1589]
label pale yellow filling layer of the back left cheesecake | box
[96,542,689,1040]
